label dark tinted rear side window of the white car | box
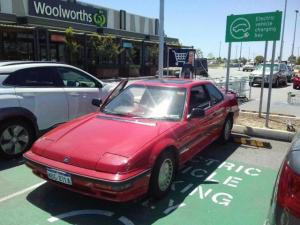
[4,67,62,87]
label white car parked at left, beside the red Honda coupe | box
[0,62,112,158]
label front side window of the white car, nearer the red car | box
[57,67,99,88]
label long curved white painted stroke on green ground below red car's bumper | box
[48,209,114,223]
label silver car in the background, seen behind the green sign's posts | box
[249,63,288,87]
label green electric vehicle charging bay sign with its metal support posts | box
[225,11,282,127]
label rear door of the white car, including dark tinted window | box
[6,67,68,130]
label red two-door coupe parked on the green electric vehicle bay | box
[24,79,238,202]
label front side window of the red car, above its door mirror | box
[189,85,210,114]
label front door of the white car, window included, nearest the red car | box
[57,67,102,120]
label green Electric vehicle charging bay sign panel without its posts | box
[225,11,282,42]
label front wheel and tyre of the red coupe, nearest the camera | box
[149,151,176,199]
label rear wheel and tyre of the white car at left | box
[0,120,35,159]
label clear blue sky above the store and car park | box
[81,0,300,59]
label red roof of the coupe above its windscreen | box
[132,78,212,88]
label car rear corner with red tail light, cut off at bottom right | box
[265,132,300,225]
